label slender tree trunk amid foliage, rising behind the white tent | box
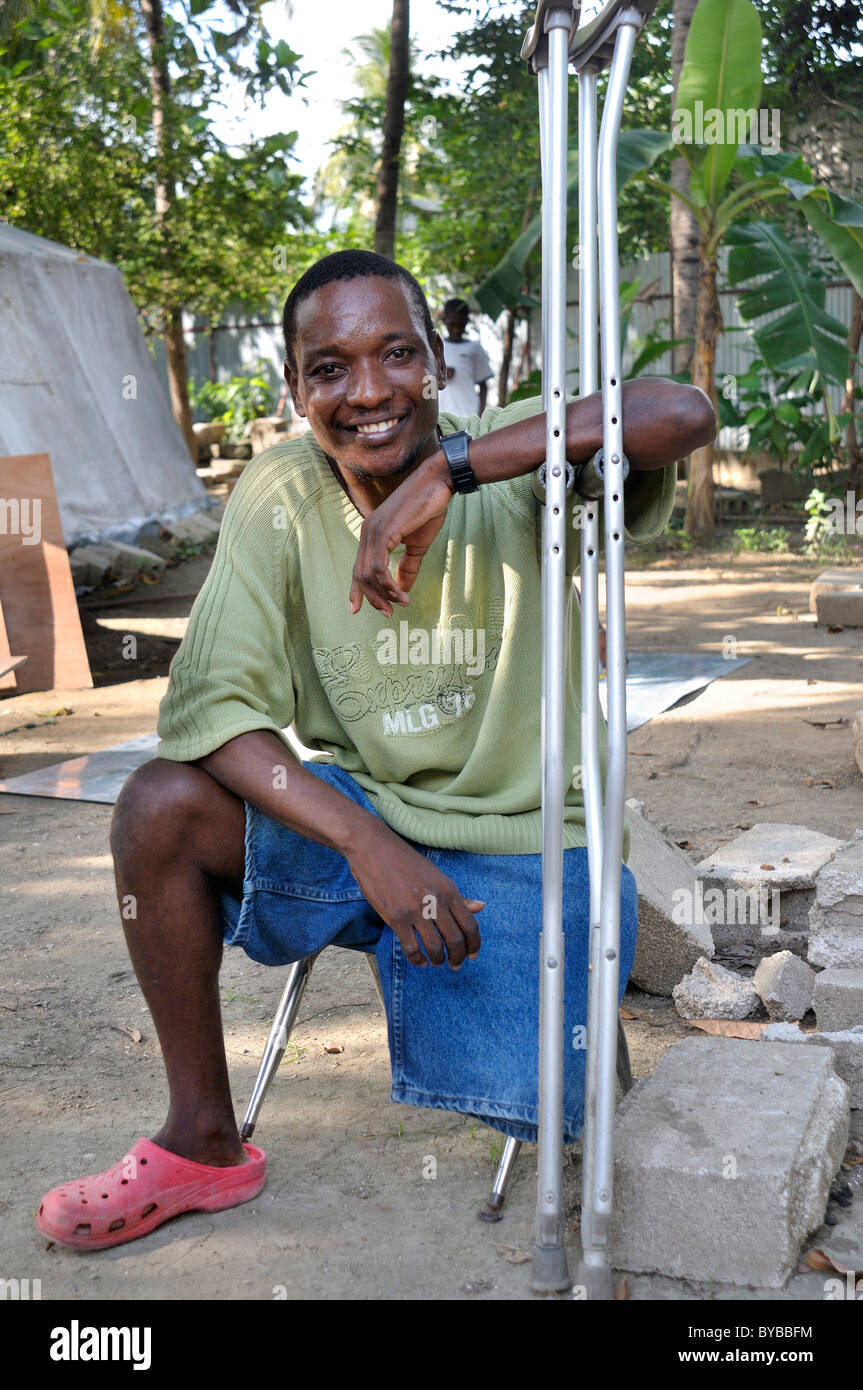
[140,0,197,463]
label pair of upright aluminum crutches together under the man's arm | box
[521,0,655,1297]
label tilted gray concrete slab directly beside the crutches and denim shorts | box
[627,802,713,995]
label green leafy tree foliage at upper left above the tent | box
[0,0,309,332]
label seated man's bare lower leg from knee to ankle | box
[111,759,246,1166]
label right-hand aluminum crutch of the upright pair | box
[571,0,656,1298]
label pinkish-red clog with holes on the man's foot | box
[36,1138,267,1250]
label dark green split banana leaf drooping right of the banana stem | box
[727,222,848,384]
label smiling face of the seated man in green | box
[285,275,446,482]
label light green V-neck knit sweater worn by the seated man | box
[158,398,675,853]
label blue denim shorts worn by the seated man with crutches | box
[222,763,638,1144]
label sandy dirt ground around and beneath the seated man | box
[0,544,863,1300]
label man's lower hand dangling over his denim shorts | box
[347,835,485,970]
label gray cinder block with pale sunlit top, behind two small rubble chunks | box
[695,823,842,959]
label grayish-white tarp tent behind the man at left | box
[0,224,208,546]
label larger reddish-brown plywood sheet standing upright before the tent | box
[0,453,93,692]
